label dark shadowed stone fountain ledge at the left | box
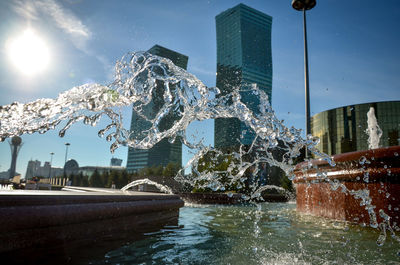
[0,188,184,254]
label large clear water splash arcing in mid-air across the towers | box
[0,52,334,194]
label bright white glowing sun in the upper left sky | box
[6,29,50,76]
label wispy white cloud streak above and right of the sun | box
[12,0,112,77]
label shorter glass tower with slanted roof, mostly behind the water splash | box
[126,45,189,172]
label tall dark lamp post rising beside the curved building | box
[292,0,317,157]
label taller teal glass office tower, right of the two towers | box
[214,4,272,149]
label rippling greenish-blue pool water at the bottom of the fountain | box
[91,203,400,264]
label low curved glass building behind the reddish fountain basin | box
[311,101,400,155]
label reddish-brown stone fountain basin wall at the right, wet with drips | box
[293,146,400,224]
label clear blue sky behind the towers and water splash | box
[0,0,400,176]
